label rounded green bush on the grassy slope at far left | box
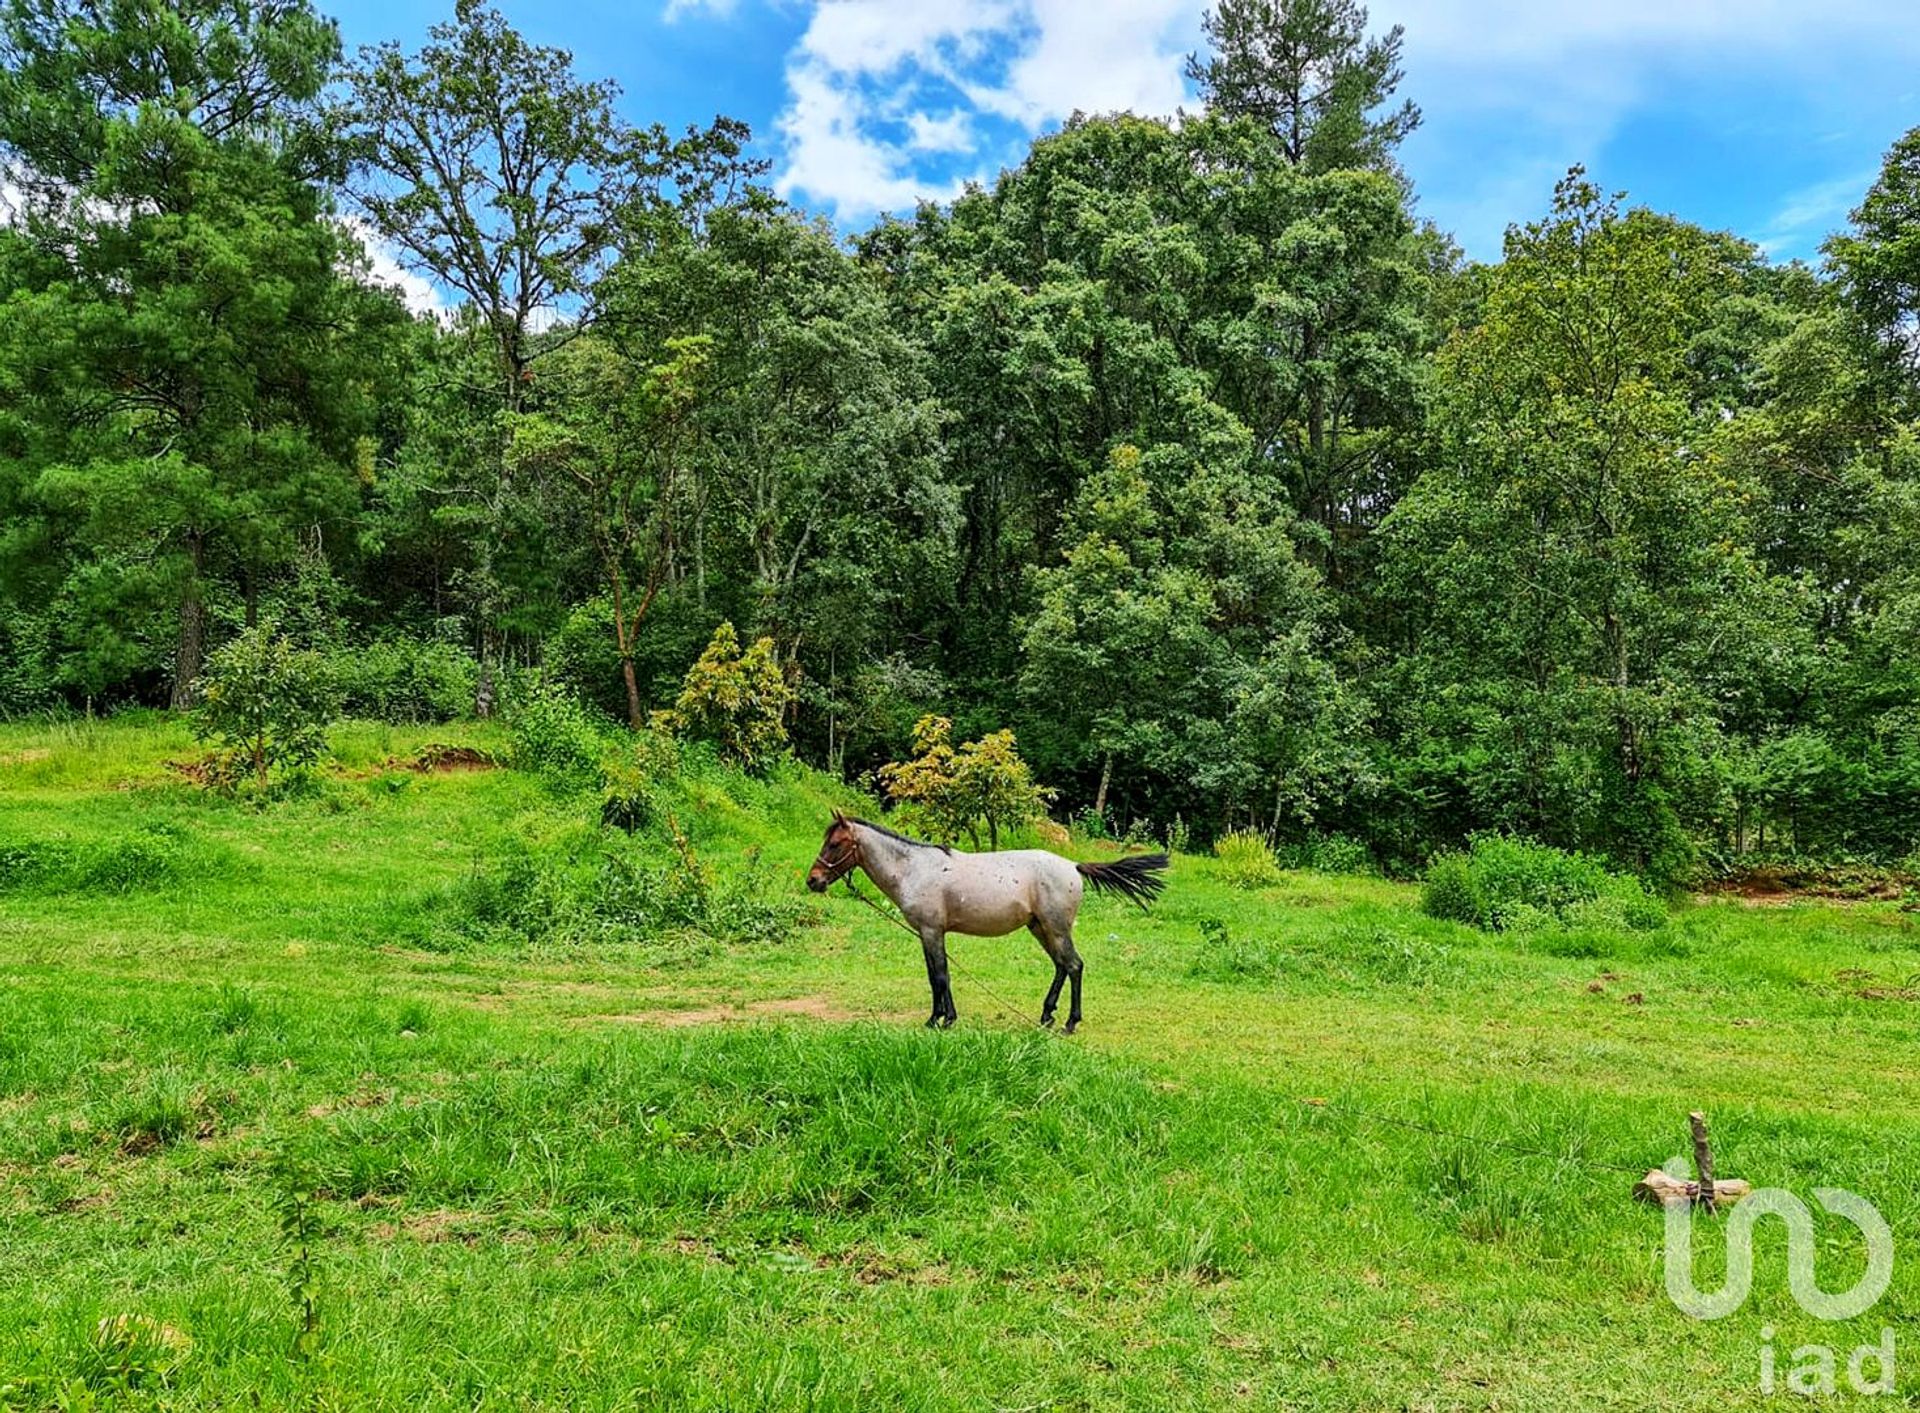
[194,624,340,789]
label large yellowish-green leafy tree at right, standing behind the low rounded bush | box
[1386,169,1805,881]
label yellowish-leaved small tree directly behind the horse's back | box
[879,716,1052,849]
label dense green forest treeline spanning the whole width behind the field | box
[0,0,1920,881]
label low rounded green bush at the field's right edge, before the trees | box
[1421,833,1667,931]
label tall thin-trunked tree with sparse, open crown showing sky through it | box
[334,0,758,699]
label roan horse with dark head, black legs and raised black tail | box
[806,810,1167,1035]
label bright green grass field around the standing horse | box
[0,720,1920,1409]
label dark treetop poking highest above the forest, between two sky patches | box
[1187,0,1421,171]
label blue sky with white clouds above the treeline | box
[319,0,1920,259]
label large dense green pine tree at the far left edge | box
[0,0,399,707]
